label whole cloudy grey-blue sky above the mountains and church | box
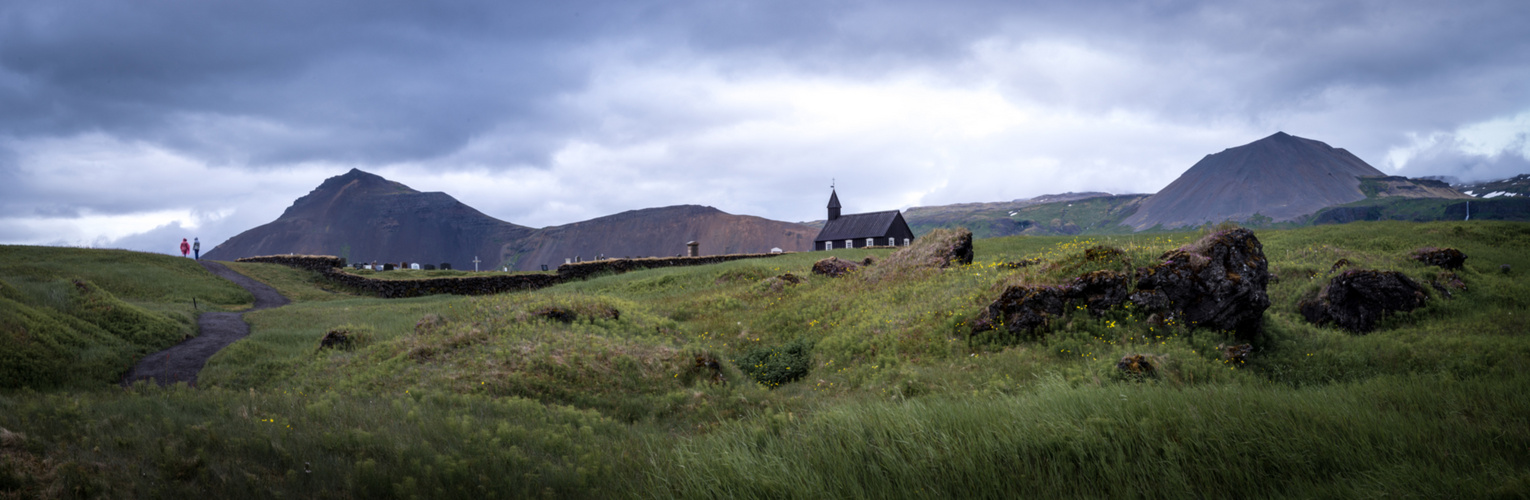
[0,0,1530,252]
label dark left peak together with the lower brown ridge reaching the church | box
[205,170,817,271]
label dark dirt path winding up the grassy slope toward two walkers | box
[122,260,289,385]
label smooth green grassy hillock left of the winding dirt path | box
[0,246,254,390]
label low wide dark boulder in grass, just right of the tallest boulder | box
[1297,269,1426,333]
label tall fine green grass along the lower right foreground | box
[644,376,1530,498]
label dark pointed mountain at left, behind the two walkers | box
[207,170,534,269]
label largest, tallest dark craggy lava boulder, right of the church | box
[1134,228,1270,339]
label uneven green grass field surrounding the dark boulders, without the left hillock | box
[0,222,1530,498]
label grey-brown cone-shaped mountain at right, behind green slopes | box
[1125,131,1386,231]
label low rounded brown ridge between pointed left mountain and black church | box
[500,205,819,271]
